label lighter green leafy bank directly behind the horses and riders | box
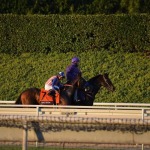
[0,51,150,103]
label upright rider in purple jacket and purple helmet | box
[66,57,82,101]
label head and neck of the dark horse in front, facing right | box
[88,73,115,91]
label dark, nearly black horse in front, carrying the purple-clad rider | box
[71,73,115,106]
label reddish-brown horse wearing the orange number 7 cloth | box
[15,78,79,105]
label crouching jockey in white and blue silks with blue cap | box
[45,72,65,97]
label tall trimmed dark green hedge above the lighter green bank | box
[0,15,150,54]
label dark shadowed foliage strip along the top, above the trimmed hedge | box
[0,0,150,15]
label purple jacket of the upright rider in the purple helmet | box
[66,64,81,81]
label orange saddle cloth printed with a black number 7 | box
[40,89,60,105]
